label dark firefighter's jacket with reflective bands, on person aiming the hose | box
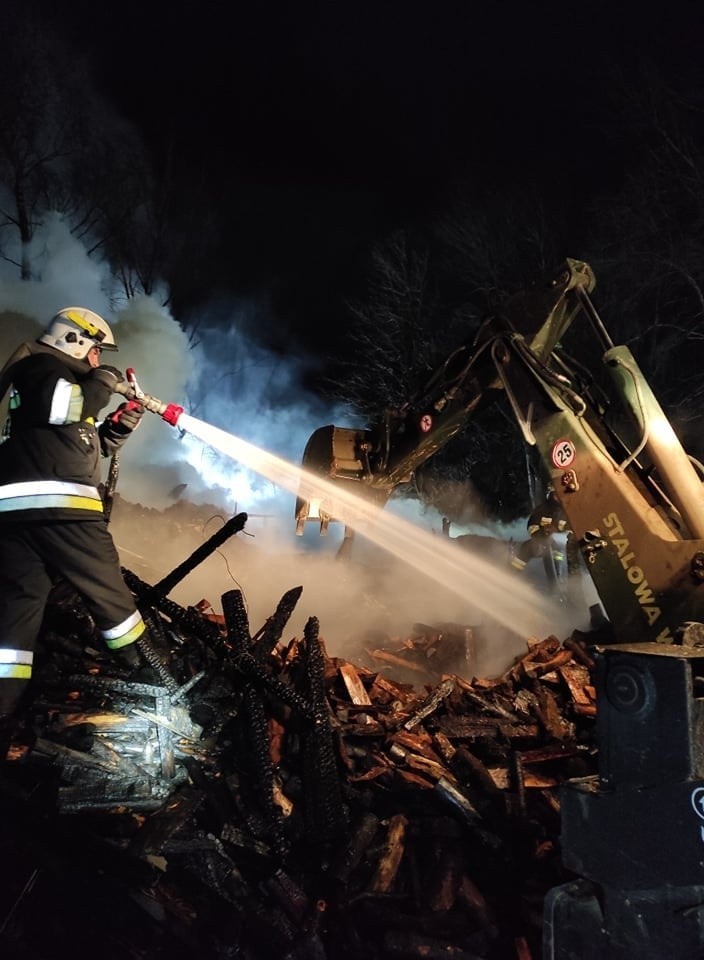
[0,344,129,523]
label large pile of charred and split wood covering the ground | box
[0,514,596,960]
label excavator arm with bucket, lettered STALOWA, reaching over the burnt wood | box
[296,259,704,643]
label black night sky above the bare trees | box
[27,0,697,360]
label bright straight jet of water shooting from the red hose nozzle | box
[178,413,568,637]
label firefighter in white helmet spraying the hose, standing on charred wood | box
[0,307,146,758]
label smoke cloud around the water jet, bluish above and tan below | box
[0,216,586,675]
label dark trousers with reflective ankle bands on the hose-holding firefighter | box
[0,519,145,715]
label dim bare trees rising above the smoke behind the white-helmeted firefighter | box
[0,0,202,299]
